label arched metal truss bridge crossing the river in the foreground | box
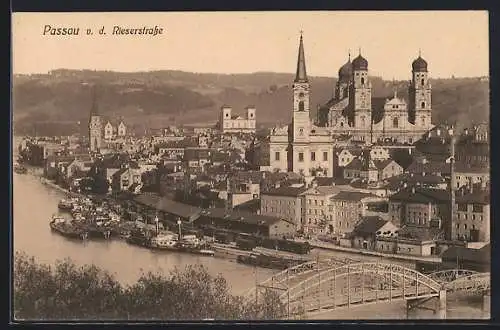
[245,260,490,319]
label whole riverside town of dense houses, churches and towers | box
[14,35,490,320]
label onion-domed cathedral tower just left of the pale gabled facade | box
[349,50,372,129]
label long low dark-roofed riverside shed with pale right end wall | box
[195,208,295,239]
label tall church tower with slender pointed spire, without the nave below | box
[292,33,310,143]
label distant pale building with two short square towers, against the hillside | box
[219,105,257,134]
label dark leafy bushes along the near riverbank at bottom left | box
[13,252,286,320]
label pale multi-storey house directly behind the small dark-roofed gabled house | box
[330,191,383,236]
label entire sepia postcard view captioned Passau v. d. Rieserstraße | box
[11,11,491,322]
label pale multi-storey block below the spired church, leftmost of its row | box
[260,186,306,230]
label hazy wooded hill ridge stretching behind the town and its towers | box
[13,69,489,134]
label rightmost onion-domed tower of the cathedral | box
[408,52,432,129]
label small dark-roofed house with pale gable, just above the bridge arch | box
[349,216,399,250]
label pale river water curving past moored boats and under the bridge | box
[13,147,489,319]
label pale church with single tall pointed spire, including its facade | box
[269,35,334,177]
